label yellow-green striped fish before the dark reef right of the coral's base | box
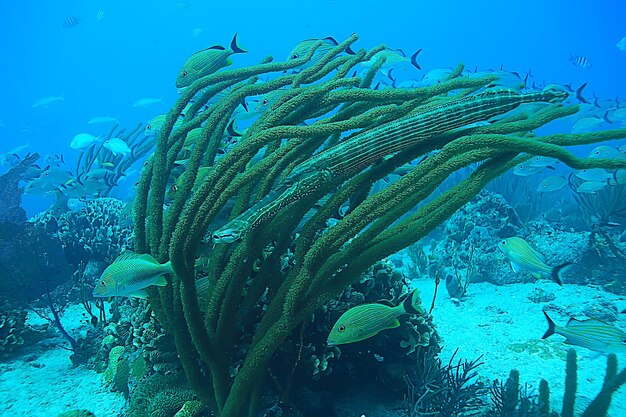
[326,288,424,346]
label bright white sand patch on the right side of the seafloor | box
[414,280,626,416]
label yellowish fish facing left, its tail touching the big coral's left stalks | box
[93,251,172,298]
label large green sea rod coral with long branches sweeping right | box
[129,35,626,417]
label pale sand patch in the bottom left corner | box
[0,306,126,417]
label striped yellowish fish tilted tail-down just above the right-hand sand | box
[498,236,571,285]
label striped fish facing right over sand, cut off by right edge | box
[542,311,626,353]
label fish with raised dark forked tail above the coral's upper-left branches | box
[176,33,248,88]
